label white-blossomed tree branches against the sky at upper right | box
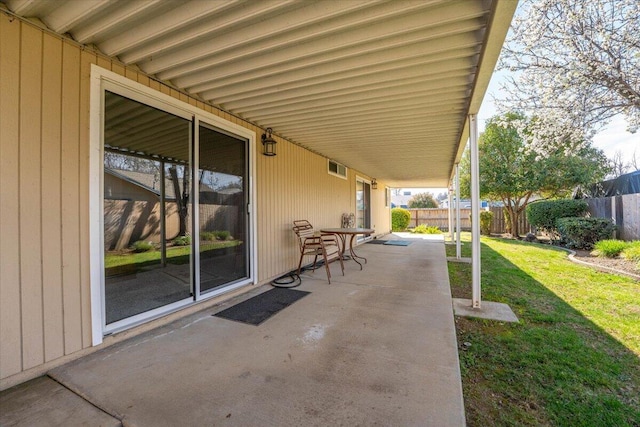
[498,0,640,155]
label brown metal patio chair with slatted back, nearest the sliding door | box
[293,219,344,283]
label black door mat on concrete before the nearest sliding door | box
[214,288,311,326]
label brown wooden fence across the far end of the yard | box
[407,207,530,234]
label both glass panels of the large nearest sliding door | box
[102,90,250,332]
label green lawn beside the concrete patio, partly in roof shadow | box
[447,234,640,426]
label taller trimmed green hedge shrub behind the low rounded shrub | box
[527,199,592,240]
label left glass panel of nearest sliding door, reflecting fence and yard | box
[103,91,193,325]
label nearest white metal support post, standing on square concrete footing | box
[469,114,481,308]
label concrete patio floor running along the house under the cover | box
[0,236,465,426]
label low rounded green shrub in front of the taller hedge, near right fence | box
[557,218,616,249]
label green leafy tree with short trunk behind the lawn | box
[460,113,607,237]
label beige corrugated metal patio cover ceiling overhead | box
[1,0,517,187]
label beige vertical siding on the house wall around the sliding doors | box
[0,13,389,388]
